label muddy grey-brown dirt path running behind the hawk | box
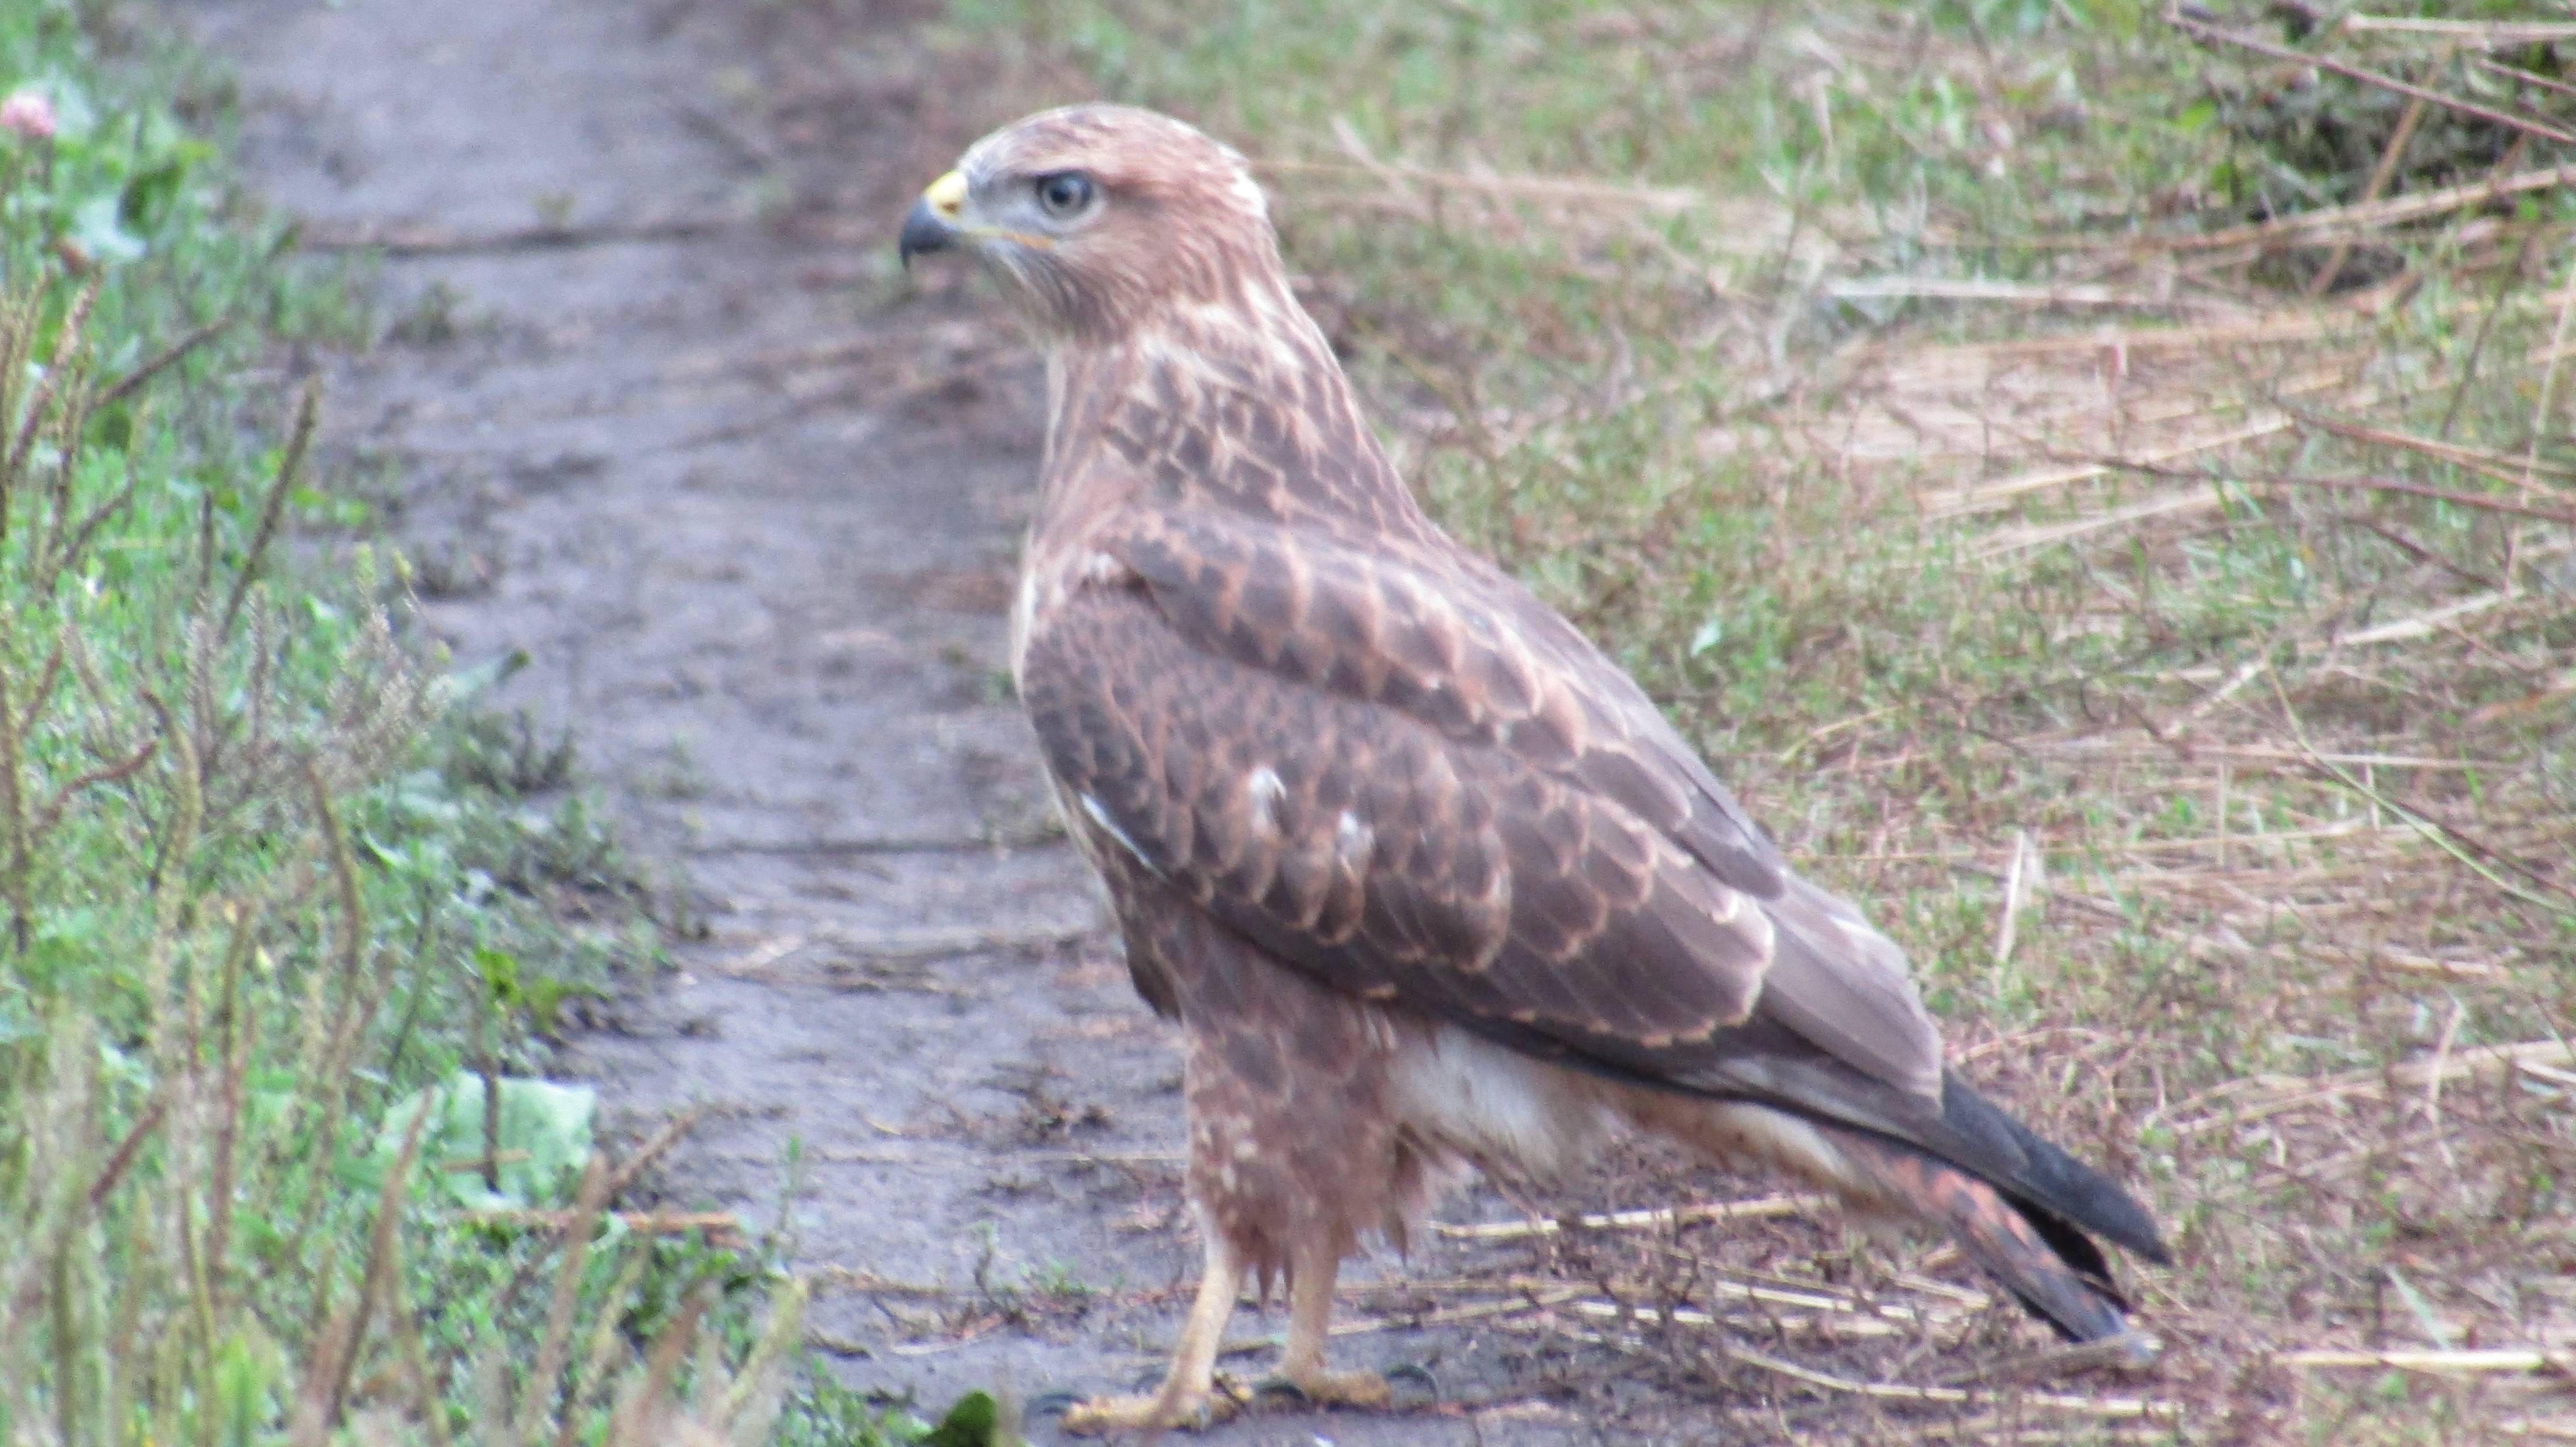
[188,0,1595,1445]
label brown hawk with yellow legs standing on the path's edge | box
[902,106,2166,1431]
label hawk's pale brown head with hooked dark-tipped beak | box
[902,106,1280,342]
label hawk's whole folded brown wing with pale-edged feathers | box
[1023,510,1940,1102]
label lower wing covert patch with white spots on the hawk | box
[1020,571,1770,1071]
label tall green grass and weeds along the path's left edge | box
[0,2,963,1445]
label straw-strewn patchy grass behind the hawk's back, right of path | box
[956,0,2576,1442]
